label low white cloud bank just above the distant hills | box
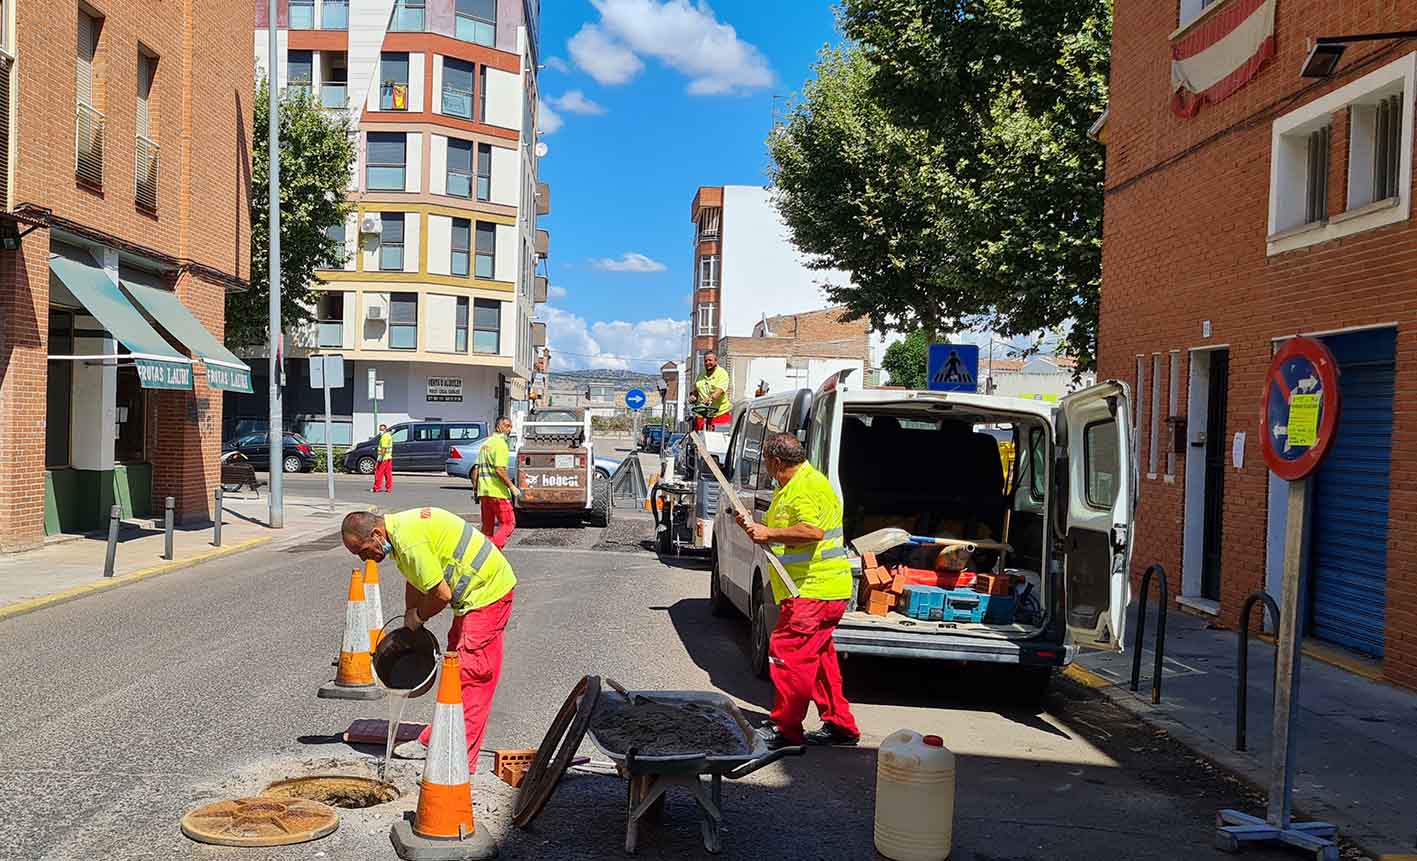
[540,304,689,372]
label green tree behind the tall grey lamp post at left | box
[227,81,356,347]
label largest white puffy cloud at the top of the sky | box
[567,0,775,95]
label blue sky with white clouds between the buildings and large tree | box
[540,0,837,371]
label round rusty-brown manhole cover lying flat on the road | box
[181,797,340,847]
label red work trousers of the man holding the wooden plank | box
[768,598,862,745]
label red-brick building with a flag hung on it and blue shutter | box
[1095,0,1417,687]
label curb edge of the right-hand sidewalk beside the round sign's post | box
[1063,663,1399,861]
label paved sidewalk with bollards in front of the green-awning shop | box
[0,490,371,619]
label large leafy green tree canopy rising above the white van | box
[769,0,1111,368]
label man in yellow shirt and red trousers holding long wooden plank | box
[738,433,862,749]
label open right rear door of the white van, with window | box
[1056,381,1138,651]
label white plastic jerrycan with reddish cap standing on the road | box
[876,729,955,861]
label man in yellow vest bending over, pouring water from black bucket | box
[343,508,517,773]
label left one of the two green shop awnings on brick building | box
[50,255,191,389]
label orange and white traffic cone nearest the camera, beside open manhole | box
[388,651,497,861]
